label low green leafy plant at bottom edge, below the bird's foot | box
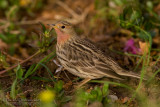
[74,83,110,107]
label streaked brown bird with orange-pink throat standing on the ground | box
[49,21,140,87]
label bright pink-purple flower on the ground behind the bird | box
[124,39,140,54]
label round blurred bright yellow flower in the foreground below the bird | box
[39,90,55,103]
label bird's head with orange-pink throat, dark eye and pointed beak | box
[49,21,76,44]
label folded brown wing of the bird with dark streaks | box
[67,38,120,79]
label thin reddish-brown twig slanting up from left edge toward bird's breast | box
[0,51,40,75]
